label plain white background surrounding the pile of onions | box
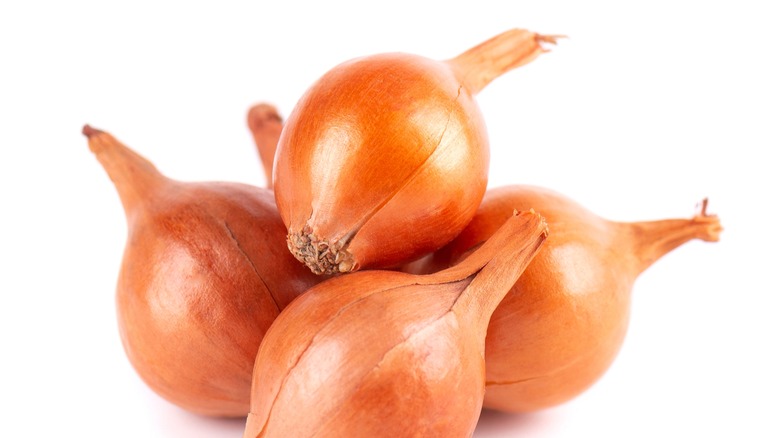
[0,0,780,438]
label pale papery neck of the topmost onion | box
[446,29,561,94]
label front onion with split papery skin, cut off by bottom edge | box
[244,210,547,438]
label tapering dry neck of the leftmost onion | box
[82,125,169,216]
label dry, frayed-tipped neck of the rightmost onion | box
[622,199,723,275]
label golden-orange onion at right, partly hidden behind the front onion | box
[406,185,722,412]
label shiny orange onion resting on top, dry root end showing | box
[273,29,556,274]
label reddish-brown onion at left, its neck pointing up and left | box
[83,126,322,417]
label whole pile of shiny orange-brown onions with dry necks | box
[83,29,721,438]
